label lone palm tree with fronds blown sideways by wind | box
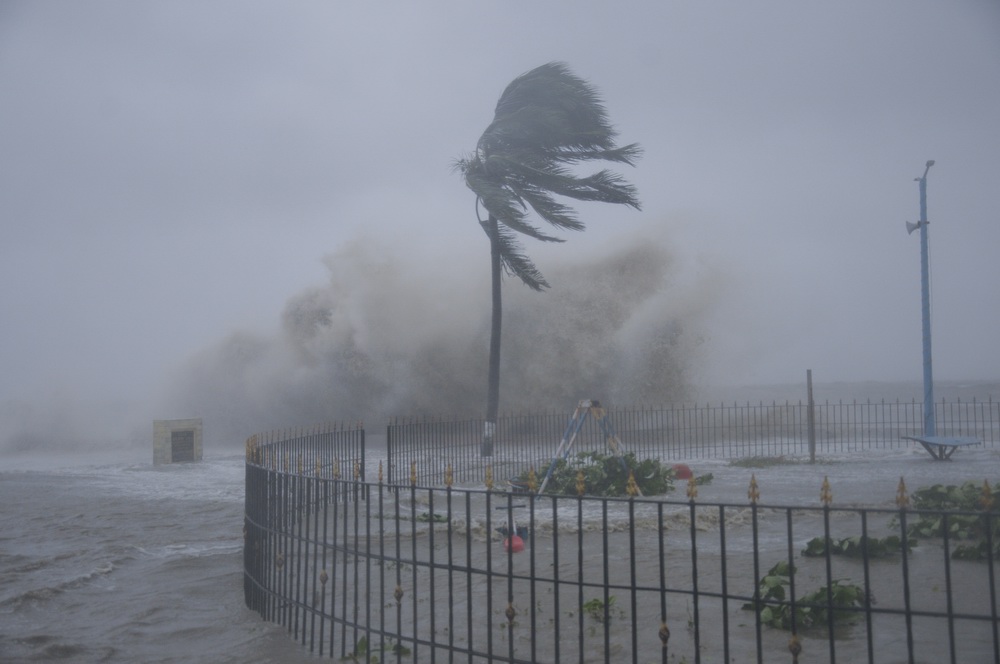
[456,62,641,456]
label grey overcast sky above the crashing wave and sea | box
[0,0,1000,440]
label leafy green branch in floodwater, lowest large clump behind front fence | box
[743,562,865,630]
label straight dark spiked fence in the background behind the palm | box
[386,398,1000,484]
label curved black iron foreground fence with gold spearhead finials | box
[244,410,1000,664]
